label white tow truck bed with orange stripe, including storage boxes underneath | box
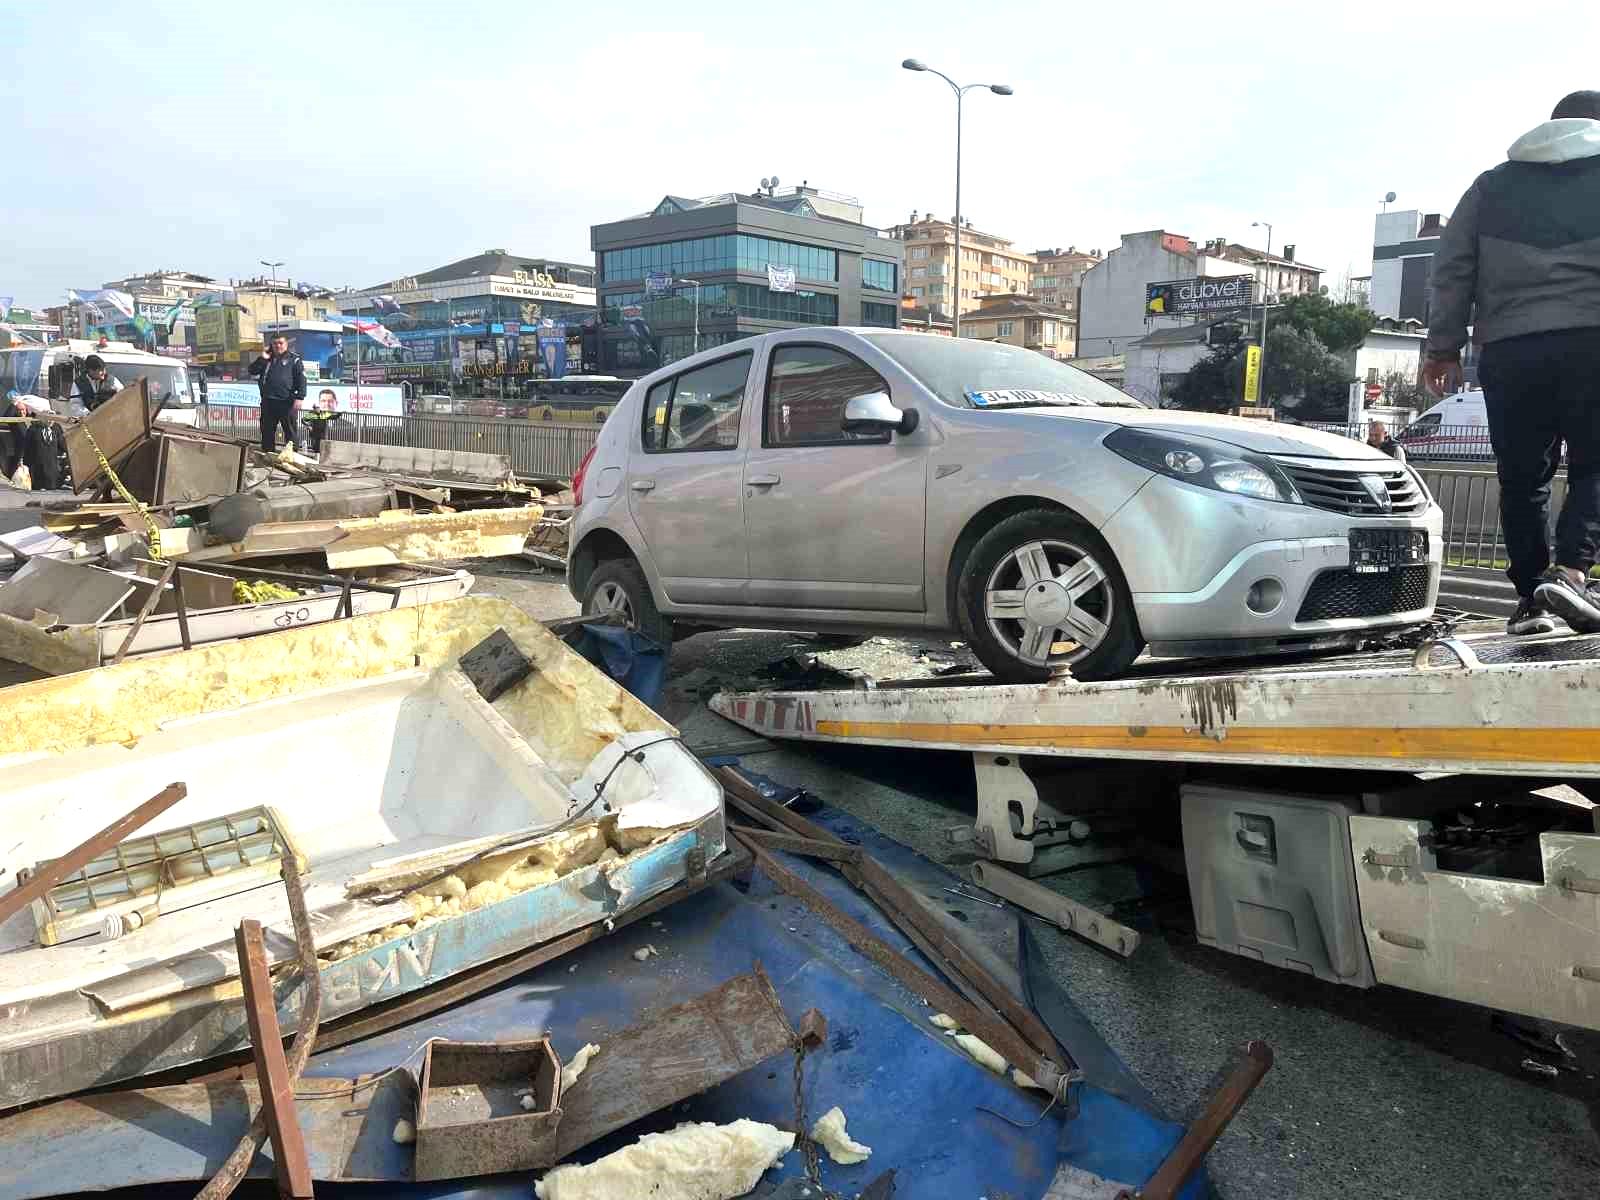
[710,632,1600,1029]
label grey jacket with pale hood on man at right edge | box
[1427,117,1600,358]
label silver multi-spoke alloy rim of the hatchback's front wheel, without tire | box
[984,539,1117,667]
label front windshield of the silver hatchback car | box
[862,333,1144,408]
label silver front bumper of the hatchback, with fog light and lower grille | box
[1104,478,1443,654]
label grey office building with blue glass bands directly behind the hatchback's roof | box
[590,186,904,374]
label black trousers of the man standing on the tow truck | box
[1478,328,1600,595]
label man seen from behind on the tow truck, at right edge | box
[1422,91,1600,634]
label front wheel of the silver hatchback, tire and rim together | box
[957,509,1144,683]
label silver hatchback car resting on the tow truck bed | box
[568,328,1442,682]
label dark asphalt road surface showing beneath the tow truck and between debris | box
[480,566,1600,1200]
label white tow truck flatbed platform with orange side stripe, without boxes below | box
[710,622,1600,778]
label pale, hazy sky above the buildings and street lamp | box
[12,0,1600,306]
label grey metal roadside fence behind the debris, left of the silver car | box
[197,405,600,478]
